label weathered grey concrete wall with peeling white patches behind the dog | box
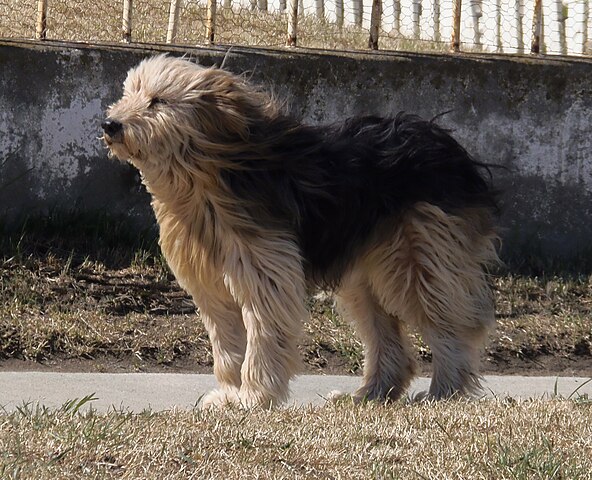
[0,42,592,268]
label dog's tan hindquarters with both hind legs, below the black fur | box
[338,203,498,399]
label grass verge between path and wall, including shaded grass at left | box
[0,217,592,375]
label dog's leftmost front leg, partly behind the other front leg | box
[193,279,247,407]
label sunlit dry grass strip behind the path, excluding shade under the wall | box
[0,254,592,373]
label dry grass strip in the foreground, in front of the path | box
[0,399,592,480]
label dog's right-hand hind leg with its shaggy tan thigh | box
[369,203,497,399]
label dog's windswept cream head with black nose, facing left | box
[101,55,272,170]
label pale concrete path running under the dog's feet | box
[0,372,592,412]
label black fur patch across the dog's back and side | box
[223,113,497,286]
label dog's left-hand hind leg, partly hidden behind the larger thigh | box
[337,273,415,401]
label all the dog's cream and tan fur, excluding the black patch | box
[104,56,497,407]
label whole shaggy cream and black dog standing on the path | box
[102,55,497,407]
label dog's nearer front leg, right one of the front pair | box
[225,235,307,407]
